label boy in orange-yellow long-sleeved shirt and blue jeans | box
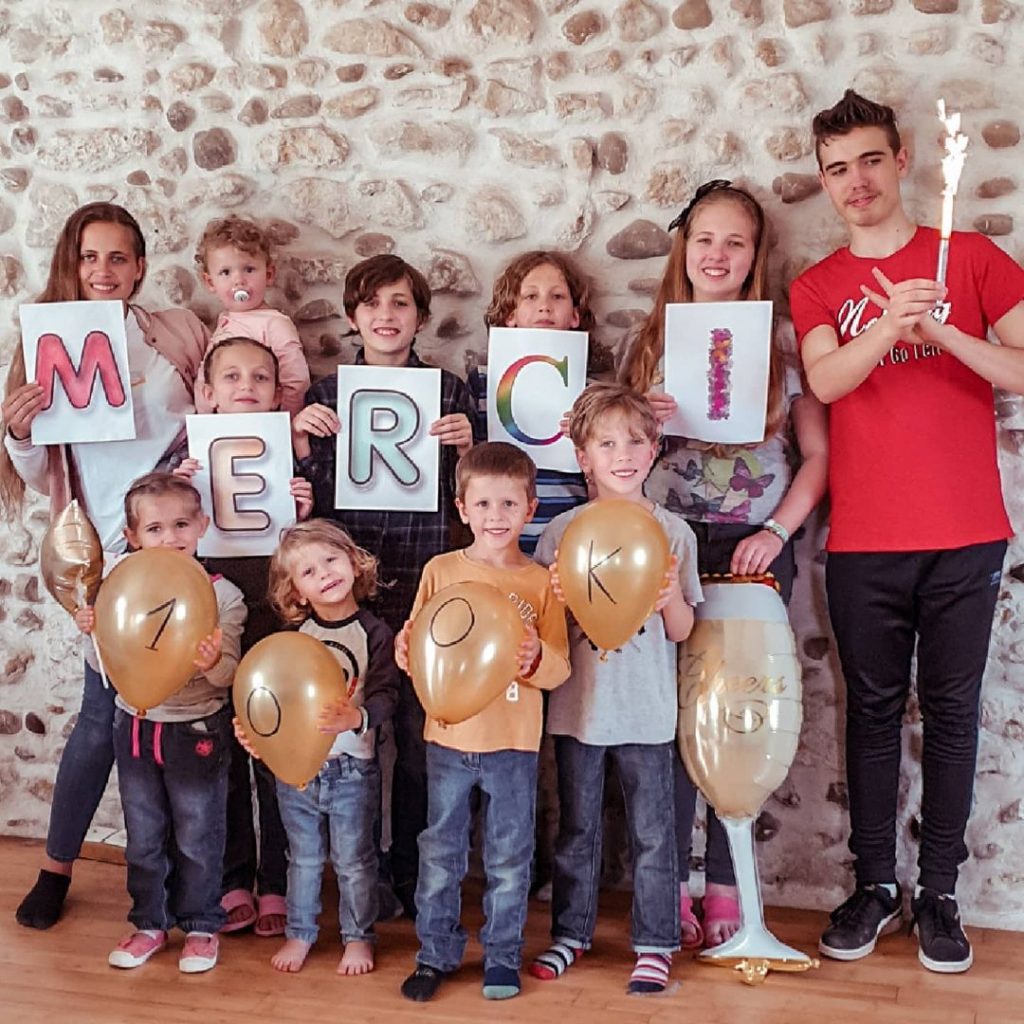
[395,441,568,1002]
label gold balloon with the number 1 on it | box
[94,548,219,712]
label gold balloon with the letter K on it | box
[558,499,672,651]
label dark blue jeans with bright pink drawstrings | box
[114,707,231,932]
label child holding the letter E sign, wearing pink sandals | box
[174,333,312,937]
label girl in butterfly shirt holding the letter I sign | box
[622,180,828,948]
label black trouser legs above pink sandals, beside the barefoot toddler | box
[221,737,288,896]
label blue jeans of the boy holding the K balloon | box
[551,736,680,953]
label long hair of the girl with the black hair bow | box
[620,181,785,438]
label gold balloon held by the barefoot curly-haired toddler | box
[232,633,346,787]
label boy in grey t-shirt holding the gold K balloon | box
[529,384,701,992]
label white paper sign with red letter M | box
[18,302,135,444]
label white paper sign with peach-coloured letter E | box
[185,413,295,558]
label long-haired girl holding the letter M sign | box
[0,203,209,928]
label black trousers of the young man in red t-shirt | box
[825,541,1007,893]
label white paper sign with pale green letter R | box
[334,366,441,512]
